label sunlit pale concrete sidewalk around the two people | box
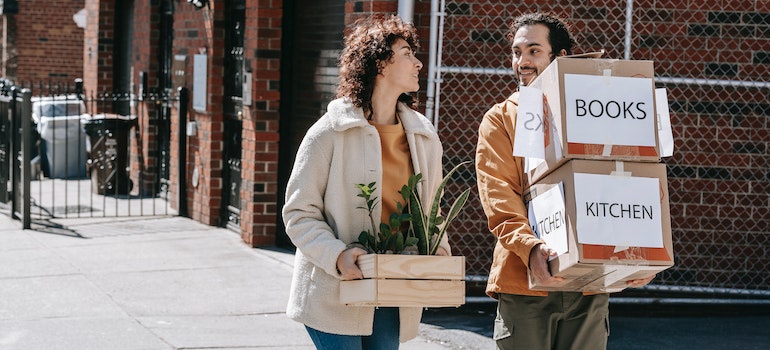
[0,214,494,350]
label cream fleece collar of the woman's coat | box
[327,98,436,136]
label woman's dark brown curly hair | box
[337,15,420,111]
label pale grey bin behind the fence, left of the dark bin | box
[32,95,88,179]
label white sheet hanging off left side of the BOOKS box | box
[513,86,547,159]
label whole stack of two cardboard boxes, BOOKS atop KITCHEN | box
[517,57,673,292]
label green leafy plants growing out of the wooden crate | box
[356,161,470,255]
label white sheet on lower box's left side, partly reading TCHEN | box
[528,183,569,258]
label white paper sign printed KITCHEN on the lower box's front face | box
[575,173,663,248]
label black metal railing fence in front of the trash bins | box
[0,83,187,227]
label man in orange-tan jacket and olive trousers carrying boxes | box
[476,13,654,350]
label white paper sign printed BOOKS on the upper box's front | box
[564,74,657,147]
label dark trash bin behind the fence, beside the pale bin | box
[83,114,136,195]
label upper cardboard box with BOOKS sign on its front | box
[519,57,660,184]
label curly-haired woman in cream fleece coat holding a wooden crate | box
[283,16,450,349]
